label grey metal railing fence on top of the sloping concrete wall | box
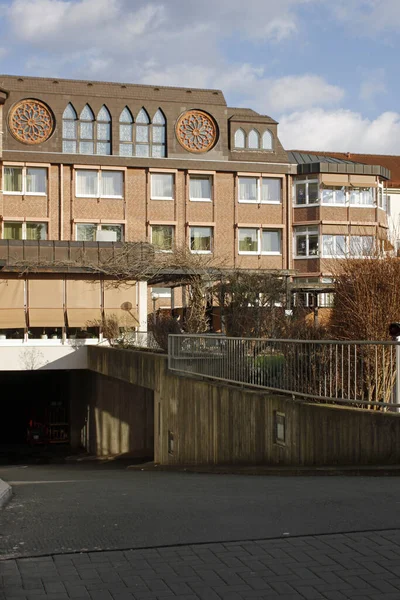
[168,335,400,412]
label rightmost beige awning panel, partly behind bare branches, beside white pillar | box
[104,282,139,327]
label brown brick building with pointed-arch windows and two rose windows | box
[0,76,389,338]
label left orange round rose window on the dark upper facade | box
[9,100,54,144]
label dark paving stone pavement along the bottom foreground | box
[0,530,400,600]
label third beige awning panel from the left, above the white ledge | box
[66,279,101,327]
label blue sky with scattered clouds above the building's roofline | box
[0,0,400,154]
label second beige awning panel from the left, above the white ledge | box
[28,279,65,327]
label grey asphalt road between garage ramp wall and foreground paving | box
[0,464,400,558]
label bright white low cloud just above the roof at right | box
[279,108,400,154]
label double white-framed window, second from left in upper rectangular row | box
[76,169,123,198]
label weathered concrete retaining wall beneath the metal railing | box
[88,347,400,465]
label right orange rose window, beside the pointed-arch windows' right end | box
[176,110,217,152]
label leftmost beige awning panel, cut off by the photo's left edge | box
[0,279,26,329]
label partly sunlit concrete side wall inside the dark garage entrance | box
[70,371,154,460]
